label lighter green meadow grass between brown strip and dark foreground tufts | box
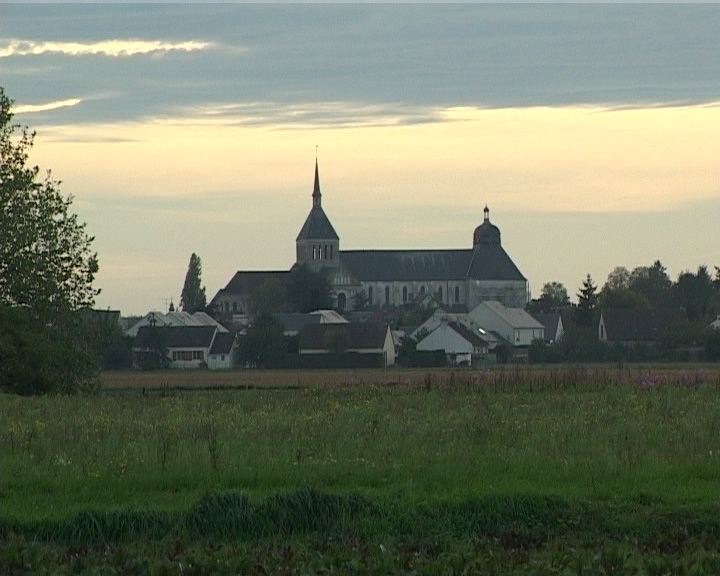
[0,369,720,521]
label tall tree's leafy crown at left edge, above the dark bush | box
[0,87,99,322]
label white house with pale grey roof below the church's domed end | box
[468,300,545,348]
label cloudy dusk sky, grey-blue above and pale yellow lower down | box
[0,4,720,314]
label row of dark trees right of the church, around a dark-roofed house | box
[527,260,720,362]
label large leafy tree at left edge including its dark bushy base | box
[0,87,99,394]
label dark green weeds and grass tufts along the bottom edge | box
[0,490,720,575]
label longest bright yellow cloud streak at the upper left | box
[0,39,211,58]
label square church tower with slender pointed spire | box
[295,158,340,272]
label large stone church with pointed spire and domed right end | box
[211,161,529,315]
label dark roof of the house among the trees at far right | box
[602,308,687,342]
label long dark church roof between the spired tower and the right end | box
[340,245,525,282]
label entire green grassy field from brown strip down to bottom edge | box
[0,368,720,574]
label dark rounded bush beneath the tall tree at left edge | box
[0,305,97,395]
